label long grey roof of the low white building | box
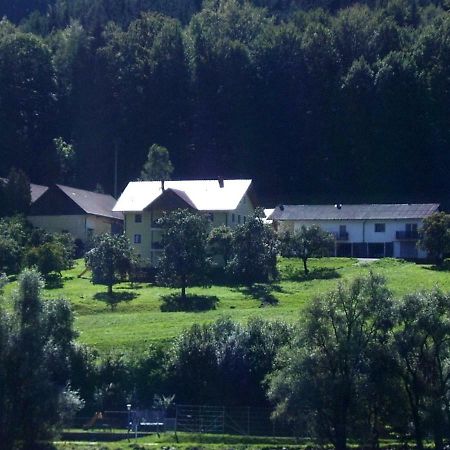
[269,203,439,220]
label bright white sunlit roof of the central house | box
[113,180,252,212]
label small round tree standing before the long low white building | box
[282,225,334,274]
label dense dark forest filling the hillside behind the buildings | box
[0,0,450,205]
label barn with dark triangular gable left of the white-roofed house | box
[28,184,123,242]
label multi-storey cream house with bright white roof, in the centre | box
[113,179,254,267]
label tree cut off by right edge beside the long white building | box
[418,212,450,265]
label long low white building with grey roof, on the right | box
[270,203,439,259]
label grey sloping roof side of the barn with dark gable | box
[56,184,123,220]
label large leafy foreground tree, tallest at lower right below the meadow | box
[269,274,394,450]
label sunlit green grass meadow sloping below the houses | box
[6,258,450,351]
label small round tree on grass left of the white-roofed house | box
[85,233,135,298]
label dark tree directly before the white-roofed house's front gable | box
[158,209,210,300]
